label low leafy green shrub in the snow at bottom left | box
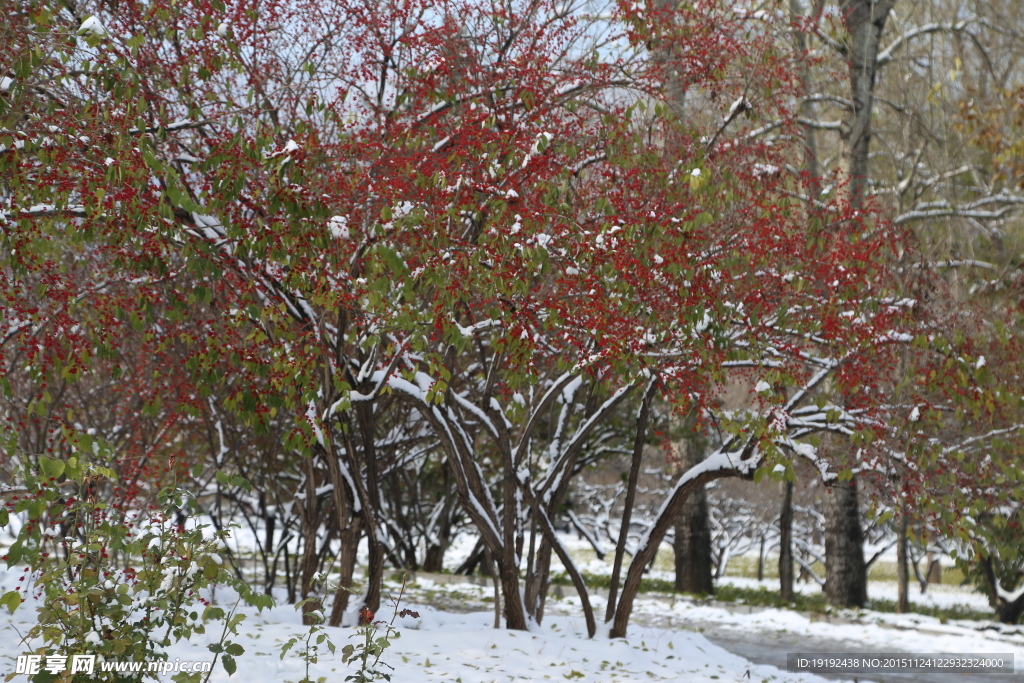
[0,450,272,683]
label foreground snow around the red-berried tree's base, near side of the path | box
[0,570,839,683]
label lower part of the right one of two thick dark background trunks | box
[824,479,867,607]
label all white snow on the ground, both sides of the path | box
[0,540,1024,683]
